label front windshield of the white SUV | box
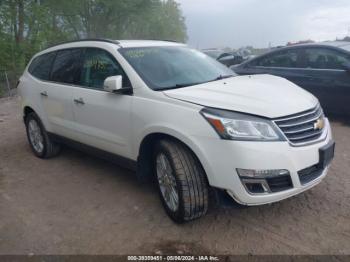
[119,46,234,90]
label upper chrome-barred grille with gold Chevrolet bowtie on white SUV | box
[274,105,324,145]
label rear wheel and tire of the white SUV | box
[25,112,61,158]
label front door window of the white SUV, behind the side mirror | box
[81,48,130,89]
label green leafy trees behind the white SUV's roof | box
[0,0,187,87]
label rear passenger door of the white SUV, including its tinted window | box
[41,48,81,138]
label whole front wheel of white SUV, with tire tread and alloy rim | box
[154,140,208,223]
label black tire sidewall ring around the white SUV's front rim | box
[153,143,185,223]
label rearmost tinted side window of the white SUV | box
[28,53,55,80]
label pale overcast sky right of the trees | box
[176,0,350,48]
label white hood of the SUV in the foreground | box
[163,75,318,118]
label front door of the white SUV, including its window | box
[72,48,133,157]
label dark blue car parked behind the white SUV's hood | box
[231,41,350,117]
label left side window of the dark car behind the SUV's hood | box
[256,50,298,68]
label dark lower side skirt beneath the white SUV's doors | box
[48,133,137,171]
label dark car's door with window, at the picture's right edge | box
[301,47,350,114]
